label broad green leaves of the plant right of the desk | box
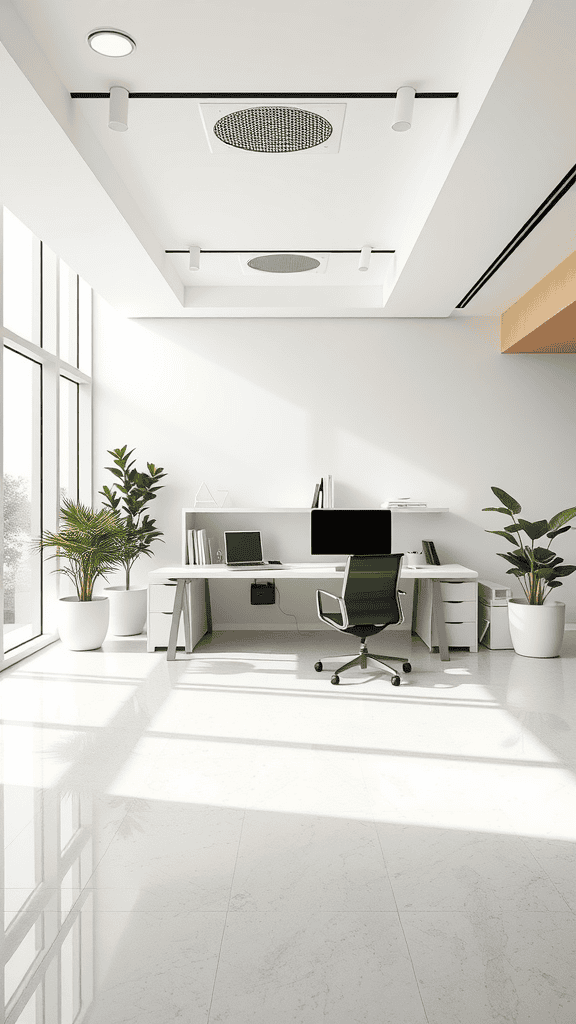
[482,487,576,604]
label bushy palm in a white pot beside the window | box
[39,498,123,650]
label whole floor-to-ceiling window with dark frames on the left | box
[0,208,92,667]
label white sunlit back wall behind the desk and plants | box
[94,300,576,622]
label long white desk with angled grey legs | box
[148,560,478,662]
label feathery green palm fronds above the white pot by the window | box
[39,498,123,601]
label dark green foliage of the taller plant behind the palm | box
[99,444,166,590]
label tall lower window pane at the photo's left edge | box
[4,347,41,651]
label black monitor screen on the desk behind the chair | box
[311,509,392,555]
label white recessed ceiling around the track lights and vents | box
[0,0,576,316]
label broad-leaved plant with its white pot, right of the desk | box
[483,487,576,657]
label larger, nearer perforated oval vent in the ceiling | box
[214,106,332,153]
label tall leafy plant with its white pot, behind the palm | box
[99,444,166,636]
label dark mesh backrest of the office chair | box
[342,554,402,626]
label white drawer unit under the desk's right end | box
[415,580,478,652]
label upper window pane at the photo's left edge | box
[3,209,35,341]
